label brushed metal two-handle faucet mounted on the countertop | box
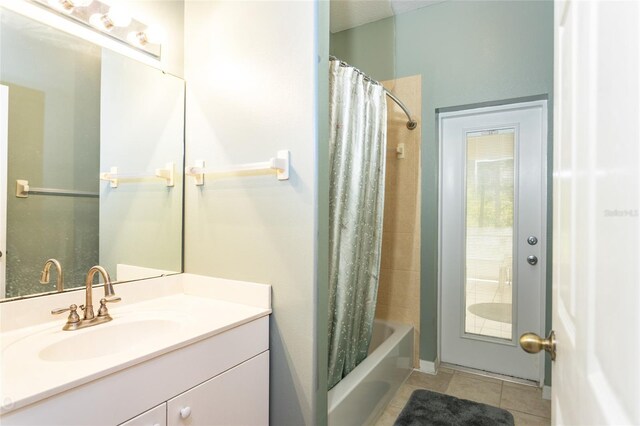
[51,265,122,330]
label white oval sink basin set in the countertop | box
[39,319,181,362]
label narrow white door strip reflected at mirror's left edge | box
[0,84,9,298]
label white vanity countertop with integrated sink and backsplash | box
[0,274,271,414]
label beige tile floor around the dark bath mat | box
[376,367,551,426]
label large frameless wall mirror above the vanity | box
[0,8,184,298]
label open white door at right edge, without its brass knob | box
[552,1,640,425]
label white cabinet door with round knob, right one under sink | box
[167,351,269,426]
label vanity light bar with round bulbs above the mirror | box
[33,0,161,59]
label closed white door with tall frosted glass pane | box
[440,101,547,382]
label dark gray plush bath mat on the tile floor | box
[394,389,514,426]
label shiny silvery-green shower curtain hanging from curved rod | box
[328,60,387,389]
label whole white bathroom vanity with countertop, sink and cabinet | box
[0,274,271,425]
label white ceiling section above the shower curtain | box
[331,0,446,33]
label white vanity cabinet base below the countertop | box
[0,314,269,426]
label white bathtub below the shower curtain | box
[328,320,413,426]
